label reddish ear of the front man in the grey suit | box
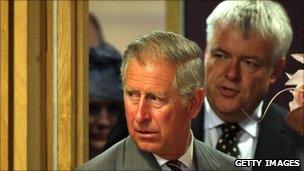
[188,88,205,119]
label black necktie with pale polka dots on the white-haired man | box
[216,123,240,157]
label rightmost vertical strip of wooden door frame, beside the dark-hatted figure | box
[76,1,89,166]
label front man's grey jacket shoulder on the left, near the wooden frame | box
[77,138,128,170]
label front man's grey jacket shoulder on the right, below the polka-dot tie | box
[194,139,250,170]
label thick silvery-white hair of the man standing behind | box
[206,0,293,63]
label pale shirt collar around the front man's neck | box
[153,130,193,169]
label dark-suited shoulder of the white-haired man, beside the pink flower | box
[255,104,304,159]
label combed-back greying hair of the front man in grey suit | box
[121,31,204,103]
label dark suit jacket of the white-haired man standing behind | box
[104,104,304,170]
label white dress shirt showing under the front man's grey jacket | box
[153,131,194,171]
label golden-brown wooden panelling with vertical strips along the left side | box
[0,0,88,170]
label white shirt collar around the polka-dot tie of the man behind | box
[204,98,263,137]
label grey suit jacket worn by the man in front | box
[77,136,249,171]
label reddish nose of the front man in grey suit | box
[135,98,150,123]
